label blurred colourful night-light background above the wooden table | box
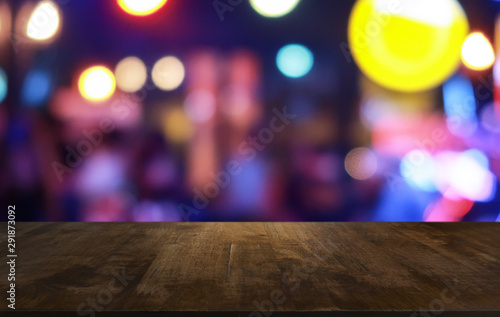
[0,0,500,221]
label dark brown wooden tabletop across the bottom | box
[0,223,500,317]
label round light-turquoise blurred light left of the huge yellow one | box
[276,44,314,78]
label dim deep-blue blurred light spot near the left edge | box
[21,69,52,106]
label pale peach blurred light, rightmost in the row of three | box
[152,56,186,91]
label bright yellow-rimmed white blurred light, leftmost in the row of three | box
[78,66,116,101]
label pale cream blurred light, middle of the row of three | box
[115,56,148,93]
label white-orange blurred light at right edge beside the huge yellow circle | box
[462,32,495,70]
